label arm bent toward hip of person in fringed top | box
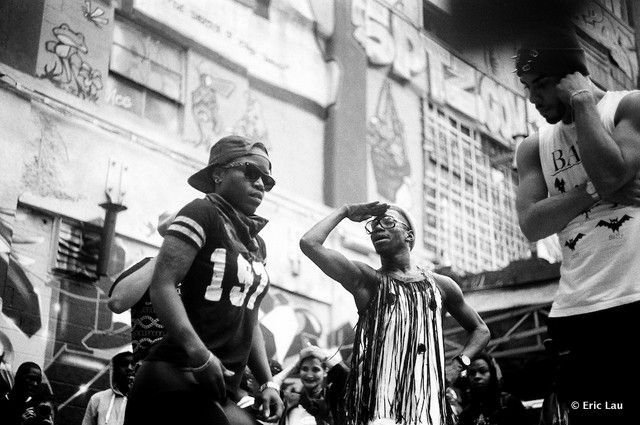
[434,275,491,382]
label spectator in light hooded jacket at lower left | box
[82,351,133,425]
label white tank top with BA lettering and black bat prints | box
[539,91,640,317]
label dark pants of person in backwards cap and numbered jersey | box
[124,361,257,425]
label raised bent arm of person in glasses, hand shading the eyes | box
[300,202,388,308]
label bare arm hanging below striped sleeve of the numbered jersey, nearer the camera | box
[151,235,232,398]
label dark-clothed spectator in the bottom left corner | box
[0,362,54,425]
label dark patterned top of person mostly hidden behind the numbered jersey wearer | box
[109,257,165,364]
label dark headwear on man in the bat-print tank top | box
[516,47,589,77]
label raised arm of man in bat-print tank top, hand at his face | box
[558,73,640,197]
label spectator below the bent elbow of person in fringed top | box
[458,352,529,425]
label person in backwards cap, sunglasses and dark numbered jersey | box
[125,136,283,424]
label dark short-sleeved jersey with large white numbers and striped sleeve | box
[149,194,269,390]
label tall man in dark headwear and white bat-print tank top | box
[516,24,640,424]
